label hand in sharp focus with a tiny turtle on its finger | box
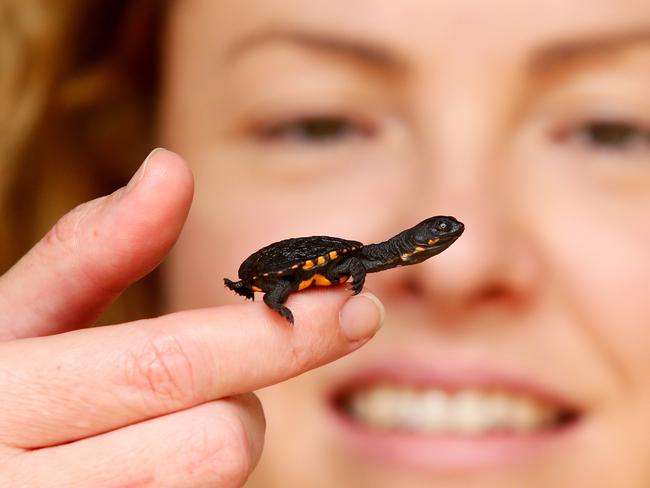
[0,151,382,488]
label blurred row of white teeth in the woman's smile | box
[346,385,559,435]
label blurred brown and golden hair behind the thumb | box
[0,0,165,321]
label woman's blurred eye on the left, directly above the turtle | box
[259,115,373,144]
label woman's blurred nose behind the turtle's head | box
[394,199,541,322]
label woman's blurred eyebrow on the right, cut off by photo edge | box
[530,28,650,71]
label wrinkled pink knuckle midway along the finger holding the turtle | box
[123,333,198,407]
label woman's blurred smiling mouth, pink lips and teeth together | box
[329,364,585,469]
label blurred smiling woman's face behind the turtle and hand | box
[160,0,650,488]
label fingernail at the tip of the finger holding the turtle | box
[339,292,384,342]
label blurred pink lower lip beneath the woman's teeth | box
[329,405,580,471]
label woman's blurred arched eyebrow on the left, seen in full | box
[226,28,405,71]
